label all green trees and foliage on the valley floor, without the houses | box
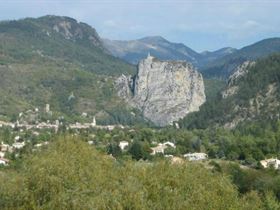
[0,122,280,210]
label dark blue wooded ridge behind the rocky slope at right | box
[201,38,280,78]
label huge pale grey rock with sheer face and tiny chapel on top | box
[116,56,206,126]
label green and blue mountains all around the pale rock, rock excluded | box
[0,15,280,127]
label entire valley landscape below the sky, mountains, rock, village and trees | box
[0,15,280,210]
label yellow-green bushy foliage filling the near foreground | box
[0,137,274,210]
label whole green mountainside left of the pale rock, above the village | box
[0,16,149,123]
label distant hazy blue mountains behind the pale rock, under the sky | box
[103,36,280,79]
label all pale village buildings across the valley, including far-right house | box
[0,104,280,169]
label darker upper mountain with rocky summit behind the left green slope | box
[0,16,136,75]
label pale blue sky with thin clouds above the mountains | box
[0,0,280,52]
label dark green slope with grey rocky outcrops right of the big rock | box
[180,54,280,128]
